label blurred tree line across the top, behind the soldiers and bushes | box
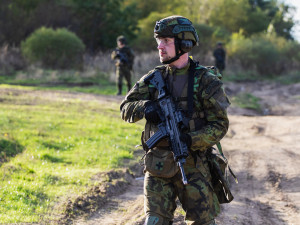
[0,0,295,52]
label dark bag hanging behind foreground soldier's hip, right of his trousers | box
[206,148,237,204]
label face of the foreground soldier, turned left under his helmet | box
[156,37,176,63]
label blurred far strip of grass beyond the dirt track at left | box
[0,69,126,95]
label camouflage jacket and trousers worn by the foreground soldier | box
[120,57,230,224]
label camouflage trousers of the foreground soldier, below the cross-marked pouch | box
[144,156,220,225]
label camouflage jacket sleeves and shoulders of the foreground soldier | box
[120,59,230,151]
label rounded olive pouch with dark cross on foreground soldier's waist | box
[144,148,179,178]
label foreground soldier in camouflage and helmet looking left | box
[120,16,230,225]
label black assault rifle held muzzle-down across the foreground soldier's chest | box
[144,71,189,185]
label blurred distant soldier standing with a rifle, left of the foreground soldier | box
[111,35,134,95]
